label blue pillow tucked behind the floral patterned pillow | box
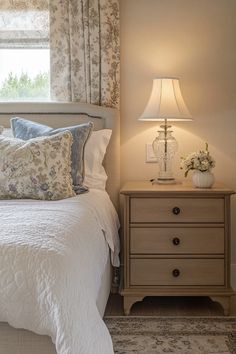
[11,117,93,194]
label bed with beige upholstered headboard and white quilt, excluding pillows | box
[0,103,119,354]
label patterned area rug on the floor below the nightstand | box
[105,316,236,354]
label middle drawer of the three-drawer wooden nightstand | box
[130,227,224,254]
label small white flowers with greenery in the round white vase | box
[180,143,215,177]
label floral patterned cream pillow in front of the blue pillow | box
[0,131,75,200]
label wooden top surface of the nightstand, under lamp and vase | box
[121,180,235,194]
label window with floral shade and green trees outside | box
[0,0,50,101]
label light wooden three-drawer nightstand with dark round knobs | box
[121,181,234,315]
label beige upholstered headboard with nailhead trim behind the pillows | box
[0,102,120,209]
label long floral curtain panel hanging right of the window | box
[50,0,120,107]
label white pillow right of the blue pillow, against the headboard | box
[84,129,112,190]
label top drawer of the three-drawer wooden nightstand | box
[130,197,224,223]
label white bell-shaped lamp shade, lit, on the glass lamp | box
[139,78,192,121]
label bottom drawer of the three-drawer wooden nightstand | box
[130,259,224,287]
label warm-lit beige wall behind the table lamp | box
[121,0,236,263]
